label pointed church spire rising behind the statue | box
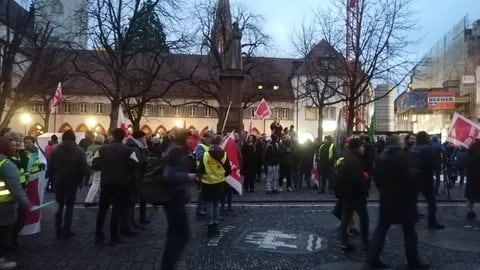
[211,0,232,67]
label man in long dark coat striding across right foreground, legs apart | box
[367,135,428,268]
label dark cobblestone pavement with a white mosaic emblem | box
[7,197,480,270]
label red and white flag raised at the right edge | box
[447,113,480,148]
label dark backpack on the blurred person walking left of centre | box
[140,157,168,204]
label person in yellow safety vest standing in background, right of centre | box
[317,135,336,194]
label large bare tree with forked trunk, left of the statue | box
[73,0,188,130]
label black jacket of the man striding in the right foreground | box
[374,146,417,224]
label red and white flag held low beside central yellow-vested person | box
[222,132,243,195]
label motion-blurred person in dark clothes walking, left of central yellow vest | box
[161,129,197,270]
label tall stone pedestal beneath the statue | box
[217,70,245,132]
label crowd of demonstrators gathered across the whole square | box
[0,121,480,269]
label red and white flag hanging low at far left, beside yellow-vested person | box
[20,171,45,235]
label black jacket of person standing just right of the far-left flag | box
[47,141,88,185]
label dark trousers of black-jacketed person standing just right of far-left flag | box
[55,182,78,233]
